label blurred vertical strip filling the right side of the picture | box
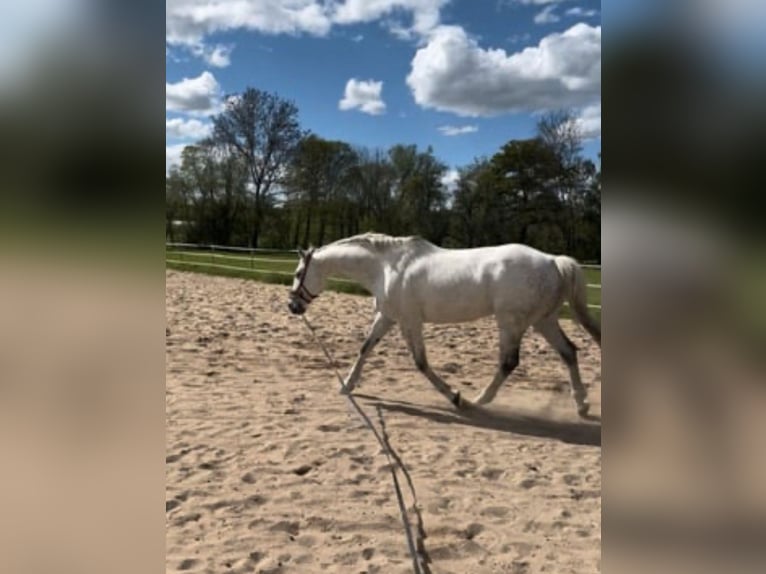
[602,0,766,573]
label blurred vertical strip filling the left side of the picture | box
[0,0,165,573]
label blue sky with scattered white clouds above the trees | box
[166,0,601,180]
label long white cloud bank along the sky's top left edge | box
[166,0,449,45]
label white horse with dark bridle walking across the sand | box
[289,233,601,416]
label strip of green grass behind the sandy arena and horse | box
[165,249,601,319]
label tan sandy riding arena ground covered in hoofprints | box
[166,271,601,574]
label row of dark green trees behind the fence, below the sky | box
[166,88,601,260]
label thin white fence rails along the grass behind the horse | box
[165,243,601,311]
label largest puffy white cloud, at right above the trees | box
[407,23,601,116]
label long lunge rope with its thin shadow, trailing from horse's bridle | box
[301,315,431,574]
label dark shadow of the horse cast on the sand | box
[354,393,601,446]
